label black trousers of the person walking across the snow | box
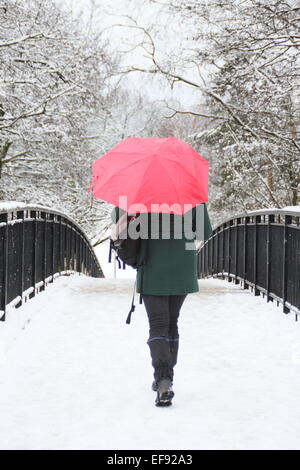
[142,294,187,382]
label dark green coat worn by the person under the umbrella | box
[112,204,212,295]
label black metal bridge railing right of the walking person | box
[198,209,300,320]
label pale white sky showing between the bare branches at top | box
[56,0,201,106]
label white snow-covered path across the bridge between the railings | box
[0,241,300,449]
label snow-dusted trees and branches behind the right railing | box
[108,0,300,221]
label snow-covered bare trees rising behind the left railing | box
[0,0,116,235]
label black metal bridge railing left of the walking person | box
[0,205,103,320]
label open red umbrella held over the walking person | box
[89,137,209,214]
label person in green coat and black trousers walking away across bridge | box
[112,203,212,406]
